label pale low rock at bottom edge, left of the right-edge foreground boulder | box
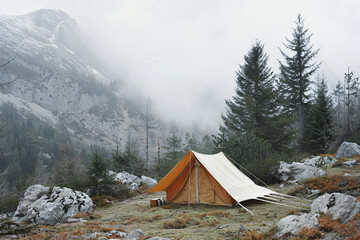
[275,213,320,237]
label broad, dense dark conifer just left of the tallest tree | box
[222,41,289,149]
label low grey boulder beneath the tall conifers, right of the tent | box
[278,161,325,181]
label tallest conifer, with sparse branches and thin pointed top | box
[279,14,321,151]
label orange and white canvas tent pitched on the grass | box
[149,151,306,210]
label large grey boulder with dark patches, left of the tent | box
[12,185,95,224]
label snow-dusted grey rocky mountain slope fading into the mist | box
[0,9,153,147]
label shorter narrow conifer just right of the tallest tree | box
[307,77,333,153]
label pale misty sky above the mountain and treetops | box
[0,0,360,131]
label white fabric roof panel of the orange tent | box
[193,151,278,203]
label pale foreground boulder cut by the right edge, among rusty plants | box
[311,193,360,222]
